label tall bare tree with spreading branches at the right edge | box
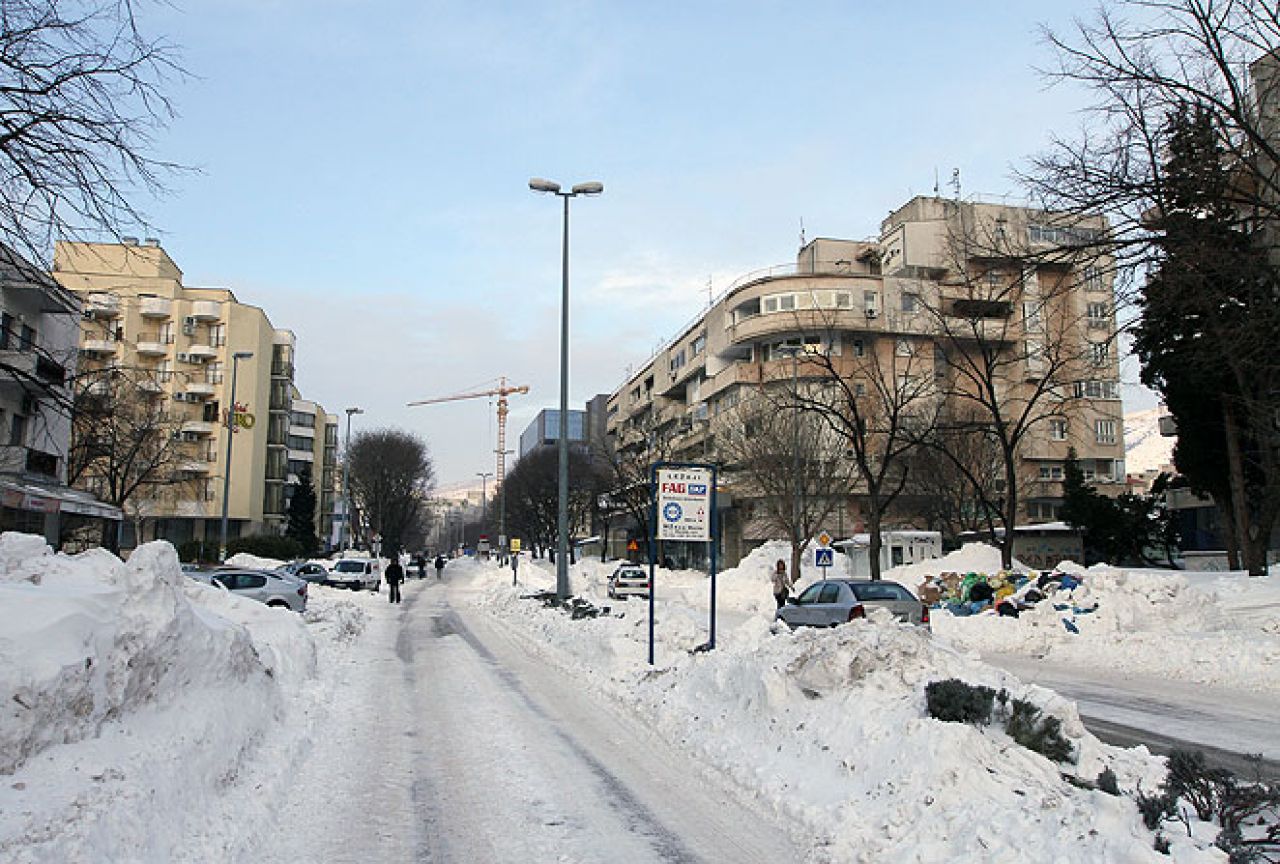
[1024,0,1280,572]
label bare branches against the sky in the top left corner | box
[0,0,183,270]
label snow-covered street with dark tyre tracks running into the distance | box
[260,580,804,864]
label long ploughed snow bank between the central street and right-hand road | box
[477,563,1220,861]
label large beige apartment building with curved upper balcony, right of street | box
[607,197,1125,566]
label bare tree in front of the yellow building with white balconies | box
[67,367,192,552]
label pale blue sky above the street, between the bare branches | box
[132,0,1152,484]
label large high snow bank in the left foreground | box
[0,534,325,861]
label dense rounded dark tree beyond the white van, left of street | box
[347,429,435,554]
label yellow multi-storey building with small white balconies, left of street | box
[52,238,338,548]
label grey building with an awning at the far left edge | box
[0,246,120,549]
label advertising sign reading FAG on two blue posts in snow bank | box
[649,462,717,666]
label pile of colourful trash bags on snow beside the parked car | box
[916,570,1098,632]
